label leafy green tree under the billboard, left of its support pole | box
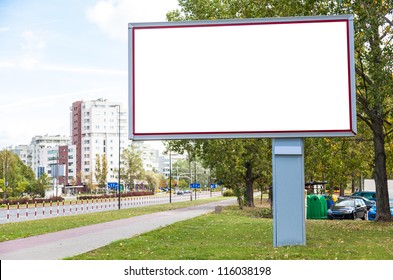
[167,139,271,207]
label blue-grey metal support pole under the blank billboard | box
[272,138,306,247]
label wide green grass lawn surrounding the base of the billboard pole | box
[67,203,393,260]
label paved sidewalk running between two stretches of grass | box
[0,199,236,260]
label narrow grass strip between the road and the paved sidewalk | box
[0,197,227,242]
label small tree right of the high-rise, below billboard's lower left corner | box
[120,145,145,189]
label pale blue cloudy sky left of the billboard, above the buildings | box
[0,0,179,150]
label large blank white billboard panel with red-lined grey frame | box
[129,16,356,140]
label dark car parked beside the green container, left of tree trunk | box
[327,198,367,220]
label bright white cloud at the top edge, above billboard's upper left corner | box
[86,0,179,41]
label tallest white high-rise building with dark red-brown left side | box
[71,99,130,185]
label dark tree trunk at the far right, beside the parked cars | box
[373,120,392,222]
